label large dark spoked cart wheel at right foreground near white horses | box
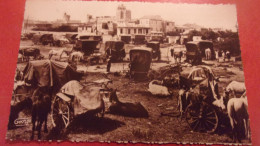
[185,102,218,133]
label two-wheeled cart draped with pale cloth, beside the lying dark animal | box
[51,79,111,129]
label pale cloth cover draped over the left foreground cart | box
[60,80,102,115]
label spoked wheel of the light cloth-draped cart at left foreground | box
[51,96,73,129]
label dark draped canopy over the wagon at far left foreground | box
[23,60,82,91]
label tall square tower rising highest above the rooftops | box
[116,4,131,23]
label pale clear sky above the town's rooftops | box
[24,0,237,30]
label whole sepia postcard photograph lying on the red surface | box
[6,0,251,145]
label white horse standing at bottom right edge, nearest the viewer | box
[227,92,250,142]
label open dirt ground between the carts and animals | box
[6,41,249,144]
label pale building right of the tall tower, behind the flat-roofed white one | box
[139,15,164,32]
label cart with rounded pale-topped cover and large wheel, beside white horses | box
[181,66,225,133]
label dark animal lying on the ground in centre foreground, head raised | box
[108,89,149,118]
